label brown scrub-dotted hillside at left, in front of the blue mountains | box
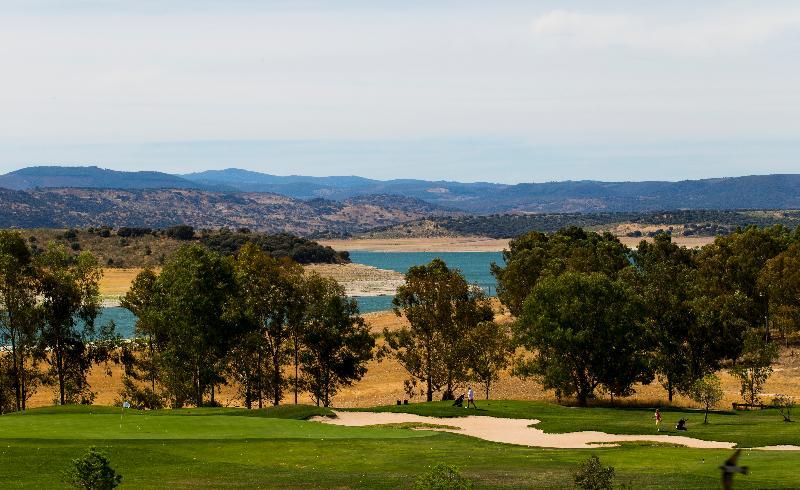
[0,188,447,235]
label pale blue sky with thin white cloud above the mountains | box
[0,0,800,183]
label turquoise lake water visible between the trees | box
[97,252,503,338]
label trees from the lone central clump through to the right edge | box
[381,226,800,405]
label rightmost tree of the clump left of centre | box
[300,279,375,407]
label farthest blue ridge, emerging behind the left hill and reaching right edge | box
[183,169,800,214]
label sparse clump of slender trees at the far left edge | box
[0,231,118,412]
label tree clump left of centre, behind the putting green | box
[121,243,375,408]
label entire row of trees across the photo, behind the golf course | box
[0,226,800,413]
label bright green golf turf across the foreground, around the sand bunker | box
[0,402,800,489]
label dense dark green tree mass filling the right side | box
[493,226,800,405]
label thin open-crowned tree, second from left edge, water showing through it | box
[36,245,104,405]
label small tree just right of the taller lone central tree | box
[466,322,513,400]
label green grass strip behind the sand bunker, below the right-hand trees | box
[356,400,800,447]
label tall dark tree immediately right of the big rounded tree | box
[626,233,697,403]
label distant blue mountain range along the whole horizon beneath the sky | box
[0,166,800,214]
